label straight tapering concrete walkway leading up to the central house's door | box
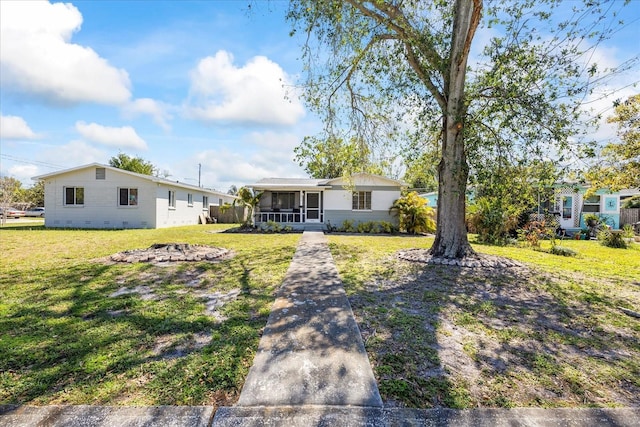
[238,231,382,407]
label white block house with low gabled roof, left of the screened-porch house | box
[33,163,236,229]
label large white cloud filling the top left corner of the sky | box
[0,1,131,104]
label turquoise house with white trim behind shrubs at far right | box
[542,182,640,231]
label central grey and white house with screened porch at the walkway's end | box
[249,173,407,229]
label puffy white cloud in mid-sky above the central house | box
[186,50,305,125]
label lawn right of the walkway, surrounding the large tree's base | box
[329,235,640,408]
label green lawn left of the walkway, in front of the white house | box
[0,224,300,405]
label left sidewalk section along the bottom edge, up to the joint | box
[0,405,214,427]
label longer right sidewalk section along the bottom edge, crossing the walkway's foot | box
[214,406,640,427]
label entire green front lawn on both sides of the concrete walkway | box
[0,224,640,408]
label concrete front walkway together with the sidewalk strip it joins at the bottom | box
[0,231,640,427]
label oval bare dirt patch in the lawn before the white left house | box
[108,243,232,264]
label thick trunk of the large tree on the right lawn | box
[431,0,482,258]
